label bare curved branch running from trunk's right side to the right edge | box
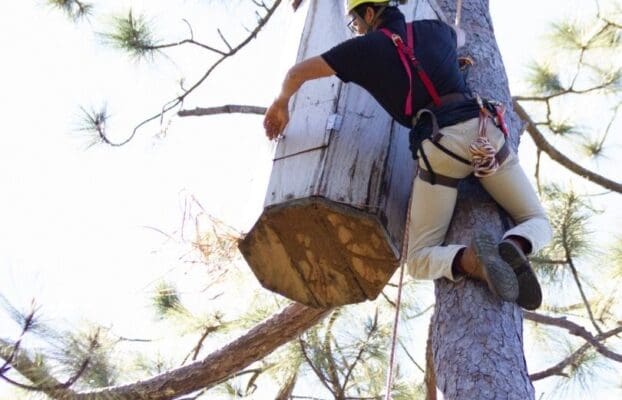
[513,97,622,193]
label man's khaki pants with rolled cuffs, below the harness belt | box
[406,118,552,280]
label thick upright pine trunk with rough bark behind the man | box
[431,0,534,400]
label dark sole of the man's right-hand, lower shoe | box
[498,241,542,310]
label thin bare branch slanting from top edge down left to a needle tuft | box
[97,0,282,147]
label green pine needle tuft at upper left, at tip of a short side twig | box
[102,10,157,59]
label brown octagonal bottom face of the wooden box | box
[240,197,400,307]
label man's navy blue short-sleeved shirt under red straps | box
[321,10,469,127]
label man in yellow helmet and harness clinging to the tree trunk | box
[264,0,551,310]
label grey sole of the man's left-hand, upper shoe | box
[473,233,519,302]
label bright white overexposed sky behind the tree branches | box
[0,0,620,397]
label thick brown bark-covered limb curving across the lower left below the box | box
[0,304,328,400]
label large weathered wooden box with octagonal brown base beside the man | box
[240,0,433,307]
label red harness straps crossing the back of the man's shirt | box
[380,22,441,117]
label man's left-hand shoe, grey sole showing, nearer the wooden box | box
[461,233,518,302]
